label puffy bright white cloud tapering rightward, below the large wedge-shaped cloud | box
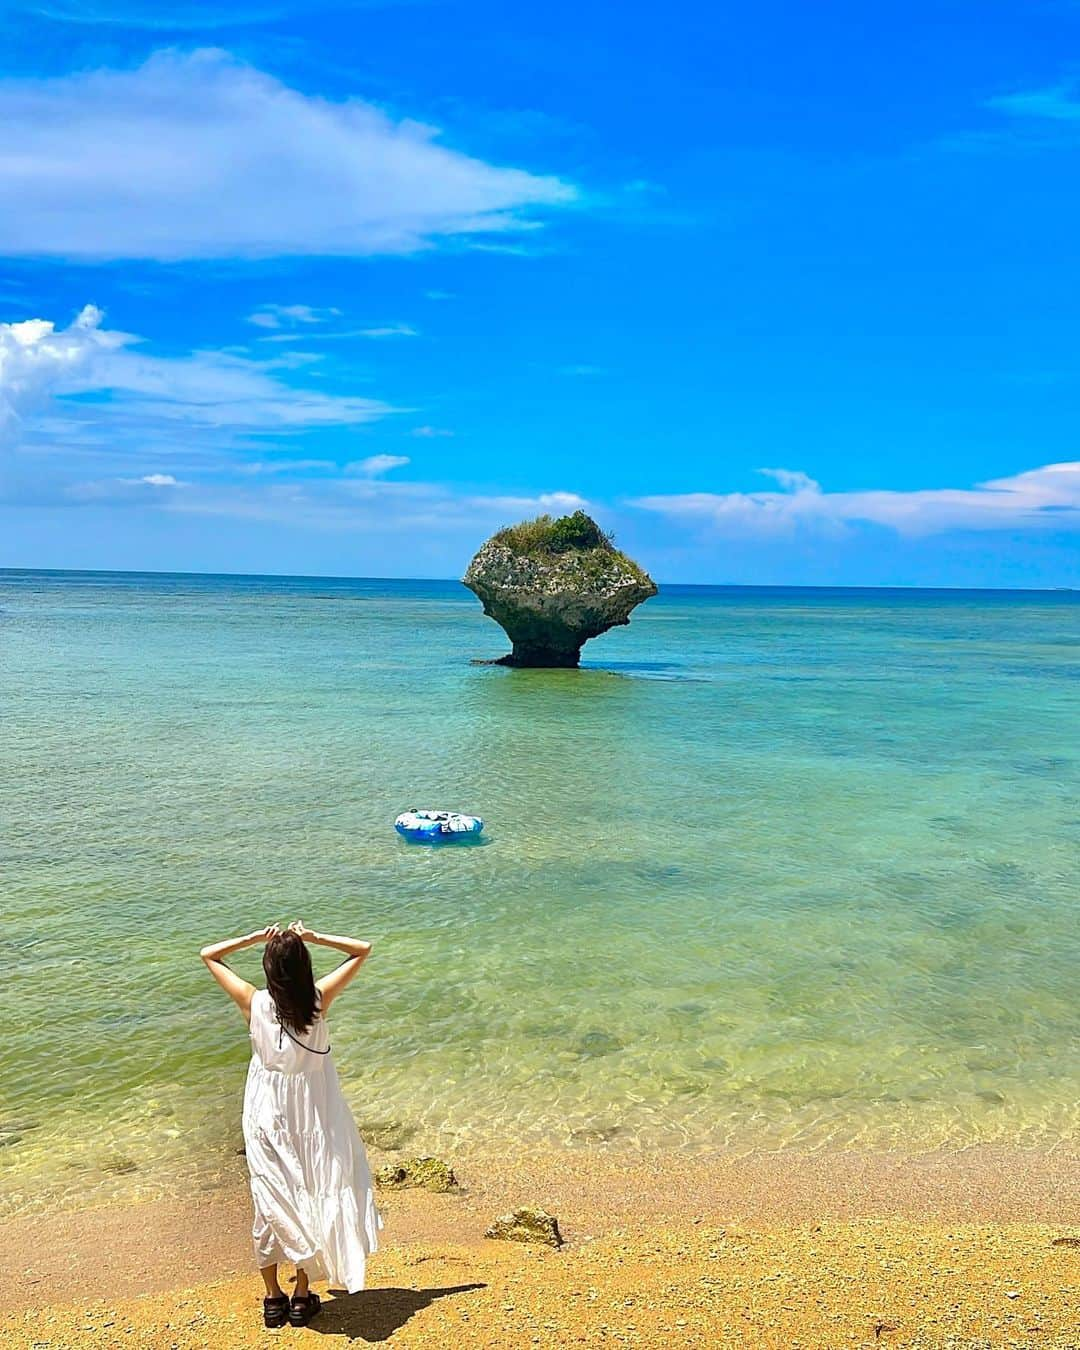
[0,305,392,441]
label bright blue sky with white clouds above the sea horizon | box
[0,0,1080,586]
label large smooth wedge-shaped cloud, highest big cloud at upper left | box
[0,50,578,259]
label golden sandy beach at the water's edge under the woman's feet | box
[0,1149,1080,1350]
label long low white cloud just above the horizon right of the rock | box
[630,460,1080,535]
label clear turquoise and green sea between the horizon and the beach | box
[0,572,1080,1211]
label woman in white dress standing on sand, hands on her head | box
[200,919,382,1327]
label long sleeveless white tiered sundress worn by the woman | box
[243,990,382,1293]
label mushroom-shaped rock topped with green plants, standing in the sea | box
[464,510,656,667]
